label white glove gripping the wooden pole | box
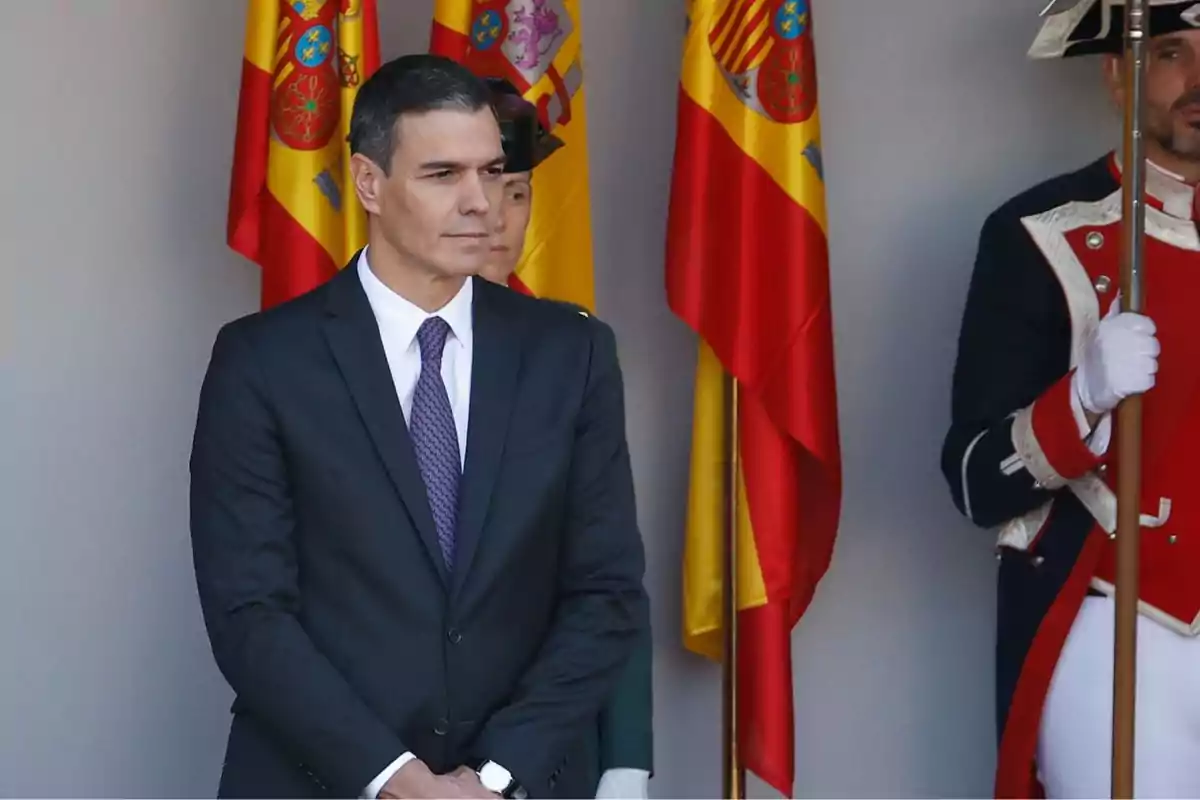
[1072,297,1160,414]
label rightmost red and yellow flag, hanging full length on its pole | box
[666,0,841,796]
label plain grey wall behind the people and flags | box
[0,0,1120,798]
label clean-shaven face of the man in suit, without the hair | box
[355,108,504,277]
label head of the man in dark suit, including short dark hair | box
[350,56,504,277]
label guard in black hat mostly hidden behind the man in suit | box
[481,78,654,800]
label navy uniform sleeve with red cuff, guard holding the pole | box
[942,210,1097,528]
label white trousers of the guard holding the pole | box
[1038,596,1200,798]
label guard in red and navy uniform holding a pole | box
[942,0,1200,798]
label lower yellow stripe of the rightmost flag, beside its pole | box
[683,342,767,660]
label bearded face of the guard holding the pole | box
[1108,31,1200,162]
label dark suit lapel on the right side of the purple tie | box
[452,279,521,595]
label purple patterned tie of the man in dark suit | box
[408,317,462,567]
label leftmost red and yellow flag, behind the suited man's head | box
[227,0,379,308]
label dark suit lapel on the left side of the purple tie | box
[324,261,450,581]
